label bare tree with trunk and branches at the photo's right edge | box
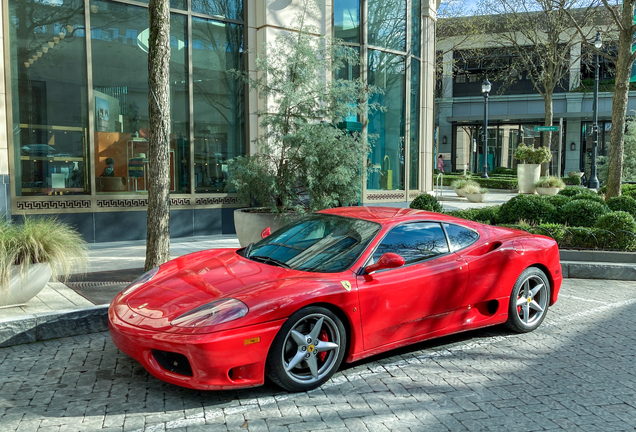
[555,0,636,198]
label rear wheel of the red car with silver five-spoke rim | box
[506,267,550,333]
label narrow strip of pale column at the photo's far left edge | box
[0,0,11,220]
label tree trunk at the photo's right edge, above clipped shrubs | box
[606,0,634,198]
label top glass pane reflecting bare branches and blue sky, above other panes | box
[368,0,406,51]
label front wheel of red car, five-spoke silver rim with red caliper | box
[267,306,347,392]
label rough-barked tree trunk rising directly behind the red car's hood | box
[145,0,170,270]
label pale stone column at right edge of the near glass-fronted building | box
[420,0,438,192]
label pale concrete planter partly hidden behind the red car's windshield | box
[234,208,300,247]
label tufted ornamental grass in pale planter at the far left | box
[0,217,87,307]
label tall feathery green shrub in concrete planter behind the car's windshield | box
[228,2,380,246]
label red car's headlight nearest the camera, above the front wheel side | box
[170,298,249,327]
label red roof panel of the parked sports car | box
[318,206,457,224]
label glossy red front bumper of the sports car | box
[108,306,285,390]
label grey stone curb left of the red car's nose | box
[0,304,109,347]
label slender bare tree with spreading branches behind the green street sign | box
[480,0,596,168]
